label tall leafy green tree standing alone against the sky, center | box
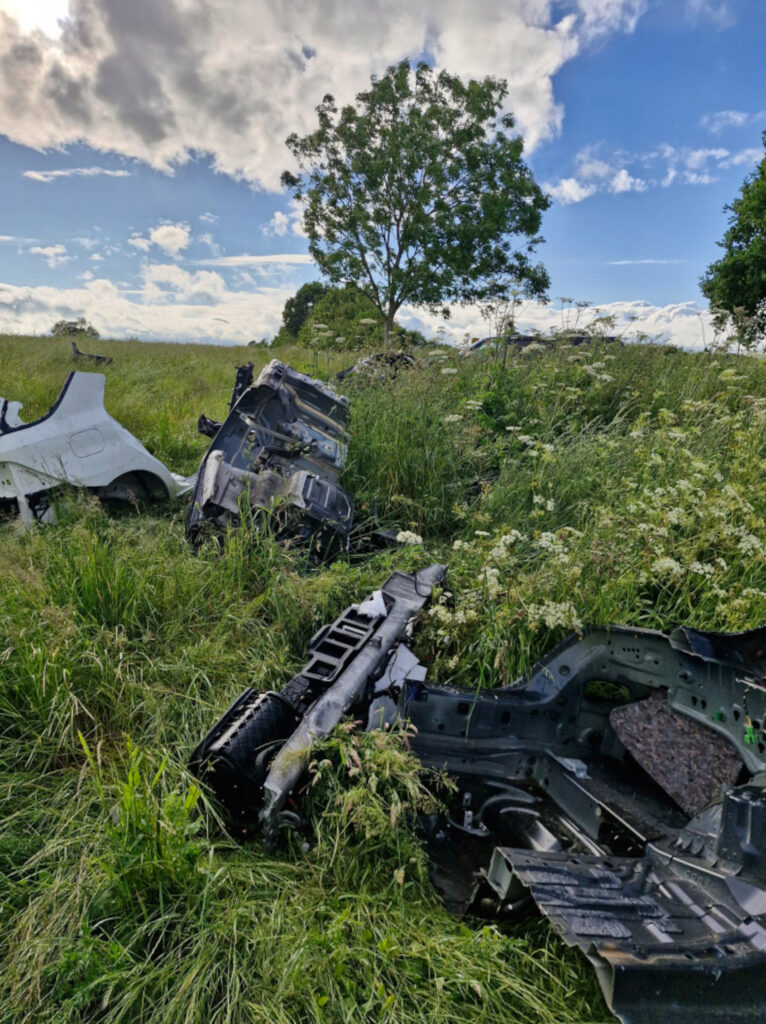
[282,60,550,348]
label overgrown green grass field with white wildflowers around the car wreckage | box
[0,338,766,1024]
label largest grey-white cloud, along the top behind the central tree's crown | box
[0,0,646,188]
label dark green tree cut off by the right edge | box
[699,132,766,346]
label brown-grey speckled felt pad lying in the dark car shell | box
[609,690,742,816]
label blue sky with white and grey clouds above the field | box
[0,0,766,347]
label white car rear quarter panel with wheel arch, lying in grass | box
[0,373,192,522]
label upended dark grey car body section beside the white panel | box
[186,359,353,559]
